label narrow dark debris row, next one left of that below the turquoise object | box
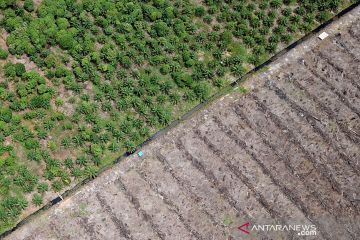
[115,179,166,240]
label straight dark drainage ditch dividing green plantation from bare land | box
[0,0,360,239]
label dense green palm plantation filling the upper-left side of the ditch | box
[0,0,350,233]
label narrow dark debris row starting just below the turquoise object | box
[137,167,205,240]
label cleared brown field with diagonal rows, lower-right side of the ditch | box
[7,5,360,240]
